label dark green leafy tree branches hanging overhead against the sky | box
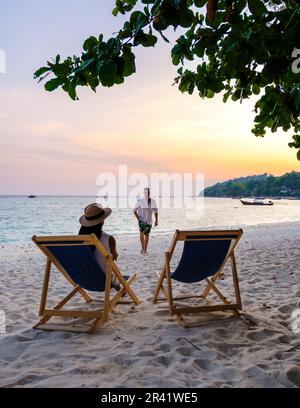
[35,0,300,160]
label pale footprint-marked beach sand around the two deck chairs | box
[0,223,300,387]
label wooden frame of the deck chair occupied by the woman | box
[32,234,140,334]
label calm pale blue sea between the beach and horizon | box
[0,197,300,244]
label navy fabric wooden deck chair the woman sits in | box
[32,234,140,333]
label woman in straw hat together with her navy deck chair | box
[32,204,140,334]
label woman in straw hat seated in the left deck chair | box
[78,203,120,290]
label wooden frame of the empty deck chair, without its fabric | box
[153,229,243,326]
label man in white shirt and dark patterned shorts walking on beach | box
[133,187,158,254]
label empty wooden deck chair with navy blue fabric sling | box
[153,229,243,326]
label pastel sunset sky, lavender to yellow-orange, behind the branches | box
[0,0,300,195]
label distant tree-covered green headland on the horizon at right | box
[204,171,300,199]
